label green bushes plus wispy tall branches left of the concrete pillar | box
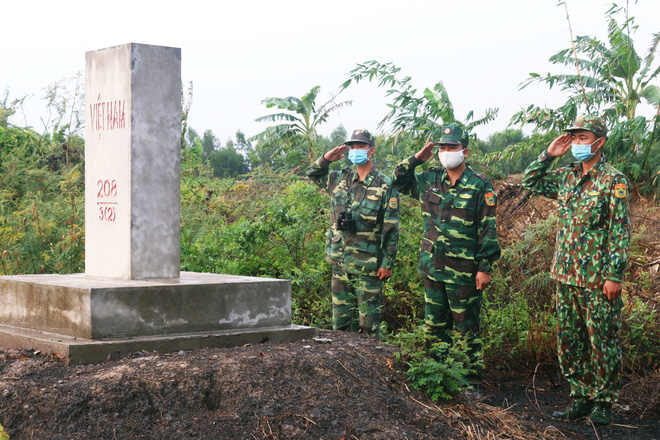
[0,78,84,275]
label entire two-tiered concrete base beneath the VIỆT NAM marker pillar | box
[0,272,315,364]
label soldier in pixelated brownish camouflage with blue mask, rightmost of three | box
[524,116,630,424]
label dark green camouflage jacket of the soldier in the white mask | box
[394,156,500,286]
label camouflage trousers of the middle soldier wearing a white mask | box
[424,278,483,371]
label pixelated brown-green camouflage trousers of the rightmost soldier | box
[557,284,623,403]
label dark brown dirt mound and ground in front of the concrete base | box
[0,330,660,440]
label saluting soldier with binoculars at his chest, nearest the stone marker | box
[307,130,399,338]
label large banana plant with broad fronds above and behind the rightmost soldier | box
[510,5,660,189]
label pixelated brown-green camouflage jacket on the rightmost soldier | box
[523,152,630,289]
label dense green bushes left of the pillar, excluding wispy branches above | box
[0,127,84,275]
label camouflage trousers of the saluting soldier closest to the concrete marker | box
[332,266,383,338]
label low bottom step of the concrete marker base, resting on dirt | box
[0,325,316,365]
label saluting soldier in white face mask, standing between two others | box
[394,124,500,385]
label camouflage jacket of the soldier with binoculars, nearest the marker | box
[307,157,399,276]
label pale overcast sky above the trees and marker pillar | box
[0,0,660,144]
